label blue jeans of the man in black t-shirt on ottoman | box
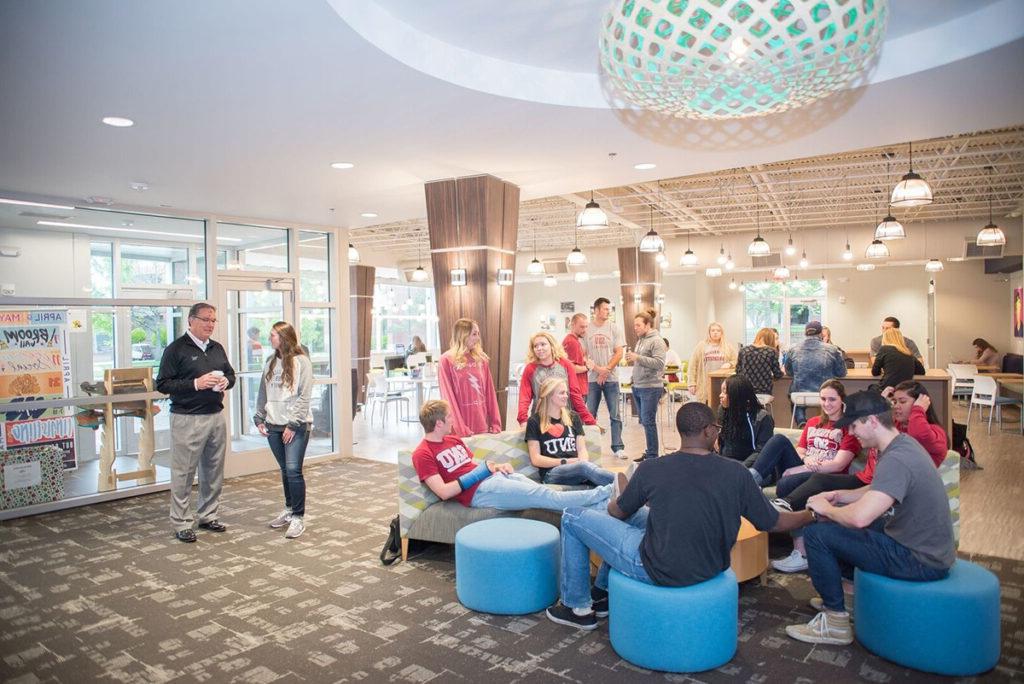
[559,507,654,608]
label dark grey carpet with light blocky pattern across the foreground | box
[0,460,1024,684]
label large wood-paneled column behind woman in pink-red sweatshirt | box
[425,175,519,423]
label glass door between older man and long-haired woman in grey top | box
[218,279,294,477]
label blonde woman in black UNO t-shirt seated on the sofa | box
[526,378,615,485]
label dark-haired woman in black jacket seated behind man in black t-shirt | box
[718,375,775,465]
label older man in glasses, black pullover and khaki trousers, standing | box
[157,302,234,543]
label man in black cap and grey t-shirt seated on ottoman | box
[785,391,956,645]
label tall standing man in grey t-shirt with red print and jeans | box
[581,297,626,459]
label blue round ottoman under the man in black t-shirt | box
[608,570,739,672]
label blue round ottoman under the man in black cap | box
[854,560,999,676]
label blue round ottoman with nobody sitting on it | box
[455,518,559,615]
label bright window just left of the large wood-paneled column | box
[370,283,440,353]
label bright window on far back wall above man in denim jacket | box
[743,280,827,347]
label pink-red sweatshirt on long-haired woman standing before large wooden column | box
[437,353,502,437]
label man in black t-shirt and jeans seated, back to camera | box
[547,401,811,630]
